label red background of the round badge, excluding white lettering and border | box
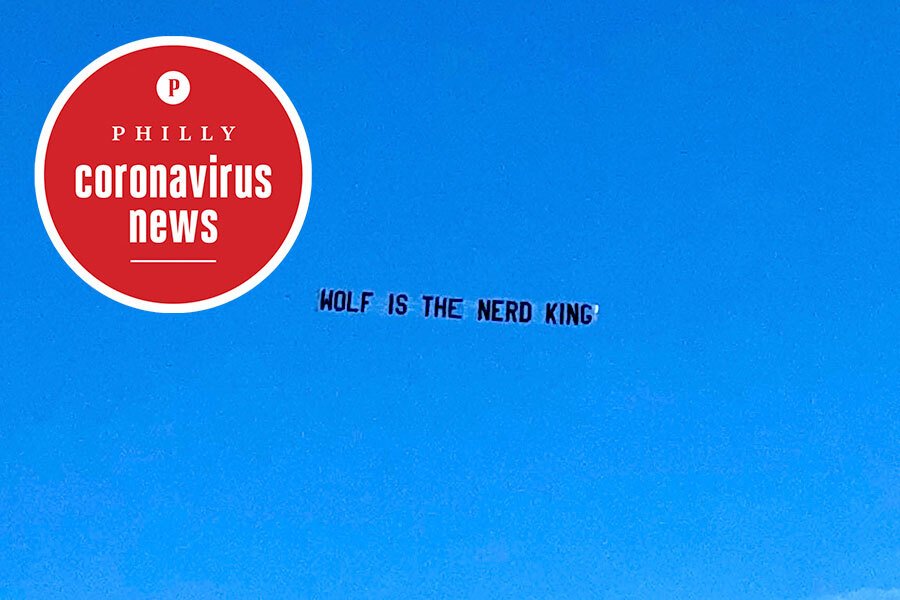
[44,46,304,303]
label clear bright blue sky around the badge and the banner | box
[0,2,900,600]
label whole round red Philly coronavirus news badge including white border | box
[35,37,311,312]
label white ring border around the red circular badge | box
[34,36,312,313]
